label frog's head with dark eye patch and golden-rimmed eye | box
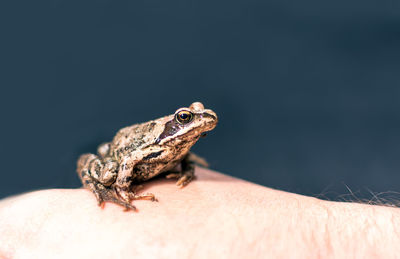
[156,102,218,144]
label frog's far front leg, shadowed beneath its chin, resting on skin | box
[166,152,208,187]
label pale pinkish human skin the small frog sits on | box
[0,168,400,258]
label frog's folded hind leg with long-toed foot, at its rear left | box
[77,154,136,210]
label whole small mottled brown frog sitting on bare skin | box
[76,102,218,210]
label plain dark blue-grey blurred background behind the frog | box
[0,0,400,203]
